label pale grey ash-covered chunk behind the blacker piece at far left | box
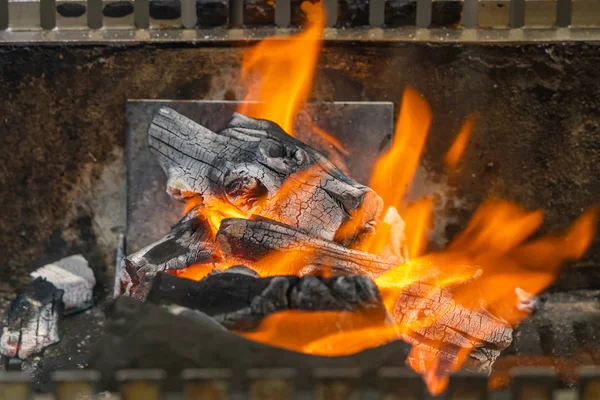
[31,255,96,313]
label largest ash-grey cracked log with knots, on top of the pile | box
[148,107,383,247]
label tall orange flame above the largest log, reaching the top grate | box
[238,2,325,134]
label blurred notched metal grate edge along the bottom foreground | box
[0,367,600,400]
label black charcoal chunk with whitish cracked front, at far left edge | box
[0,278,64,359]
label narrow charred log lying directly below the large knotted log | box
[216,218,394,278]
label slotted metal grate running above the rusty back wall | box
[0,0,600,43]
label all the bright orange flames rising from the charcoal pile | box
[177,3,597,394]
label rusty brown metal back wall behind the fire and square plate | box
[0,43,600,306]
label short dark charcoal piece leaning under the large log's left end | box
[120,207,217,300]
